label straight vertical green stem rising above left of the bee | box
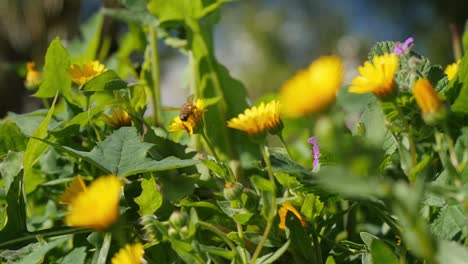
[149,26,161,126]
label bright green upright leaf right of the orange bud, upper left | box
[34,38,71,98]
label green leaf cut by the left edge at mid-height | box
[0,121,28,156]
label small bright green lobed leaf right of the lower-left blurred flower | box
[134,177,162,216]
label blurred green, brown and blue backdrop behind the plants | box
[0,0,468,117]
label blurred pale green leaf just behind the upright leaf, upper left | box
[68,12,104,63]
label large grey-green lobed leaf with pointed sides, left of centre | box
[49,127,199,177]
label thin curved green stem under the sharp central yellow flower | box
[250,144,276,263]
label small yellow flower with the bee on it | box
[169,99,207,134]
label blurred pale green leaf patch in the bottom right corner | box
[437,240,468,264]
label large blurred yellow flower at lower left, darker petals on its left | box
[60,175,122,230]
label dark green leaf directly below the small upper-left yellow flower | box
[83,70,127,92]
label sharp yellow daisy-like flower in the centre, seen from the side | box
[227,100,283,135]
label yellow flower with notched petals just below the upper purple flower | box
[349,53,398,97]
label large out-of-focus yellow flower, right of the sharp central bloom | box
[280,56,343,118]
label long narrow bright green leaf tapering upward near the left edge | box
[23,95,57,194]
